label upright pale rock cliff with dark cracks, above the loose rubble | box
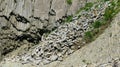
[0,0,95,54]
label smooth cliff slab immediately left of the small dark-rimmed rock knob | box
[34,0,51,20]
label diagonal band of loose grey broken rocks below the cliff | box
[0,1,109,65]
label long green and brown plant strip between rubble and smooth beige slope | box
[84,0,120,43]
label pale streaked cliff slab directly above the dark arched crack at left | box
[12,0,32,19]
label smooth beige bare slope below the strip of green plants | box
[1,10,120,67]
